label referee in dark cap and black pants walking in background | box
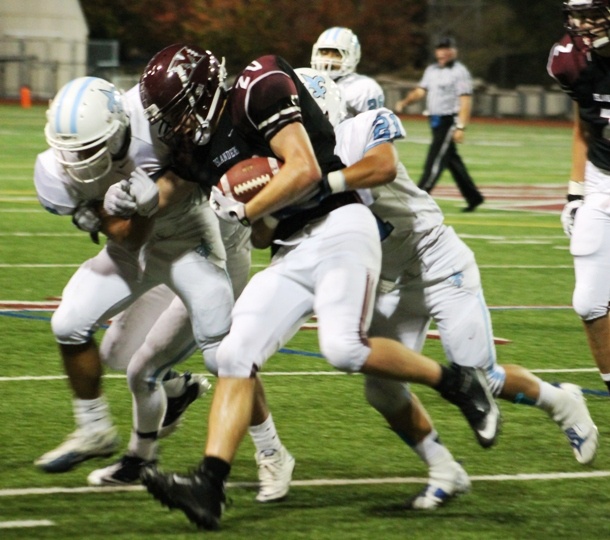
[395,37,484,212]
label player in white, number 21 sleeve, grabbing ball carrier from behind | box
[297,69,597,508]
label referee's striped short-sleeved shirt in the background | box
[419,60,472,116]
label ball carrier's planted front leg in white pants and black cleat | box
[142,239,313,529]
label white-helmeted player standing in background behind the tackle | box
[311,27,385,116]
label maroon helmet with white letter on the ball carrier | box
[140,43,226,145]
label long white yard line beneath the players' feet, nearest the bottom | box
[0,471,610,497]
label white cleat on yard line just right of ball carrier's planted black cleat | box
[254,446,295,502]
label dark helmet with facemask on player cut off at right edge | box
[562,0,610,49]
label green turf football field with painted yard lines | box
[0,105,610,540]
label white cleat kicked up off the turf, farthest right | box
[551,383,598,465]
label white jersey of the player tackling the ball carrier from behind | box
[335,109,459,281]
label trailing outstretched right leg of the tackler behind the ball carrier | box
[424,229,597,463]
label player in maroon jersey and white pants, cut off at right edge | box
[547,0,610,391]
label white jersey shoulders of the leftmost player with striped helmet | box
[34,85,169,215]
